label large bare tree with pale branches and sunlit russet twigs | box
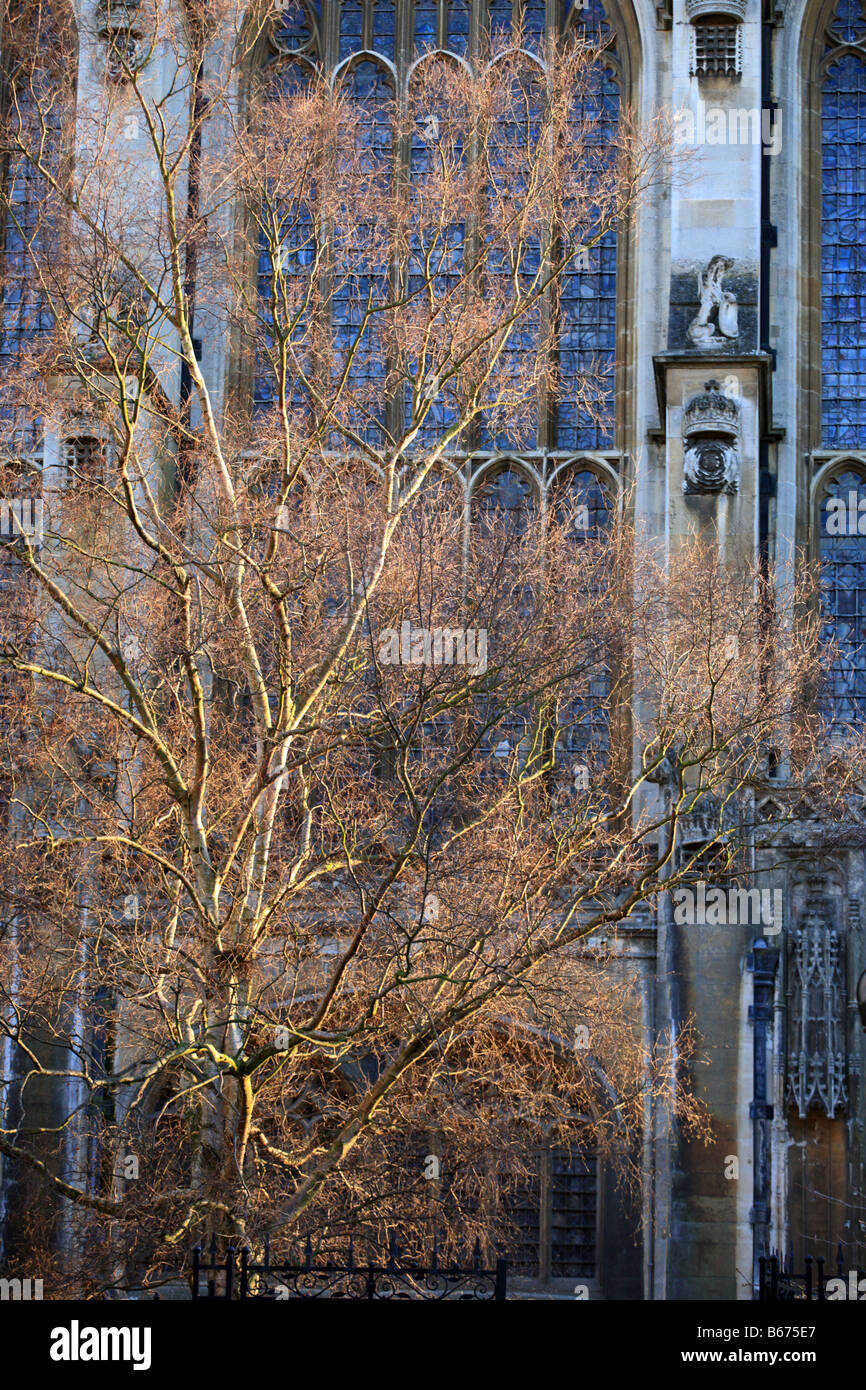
[0,4,844,1286]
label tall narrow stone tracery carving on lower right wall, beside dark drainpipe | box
[787,878,848,1119]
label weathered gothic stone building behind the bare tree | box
[0,0,866,1300]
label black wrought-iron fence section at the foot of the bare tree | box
[190,1240,507,1302]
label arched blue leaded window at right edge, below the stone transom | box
[819,468,866,727]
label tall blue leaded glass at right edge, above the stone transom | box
[822,54,866,449]
